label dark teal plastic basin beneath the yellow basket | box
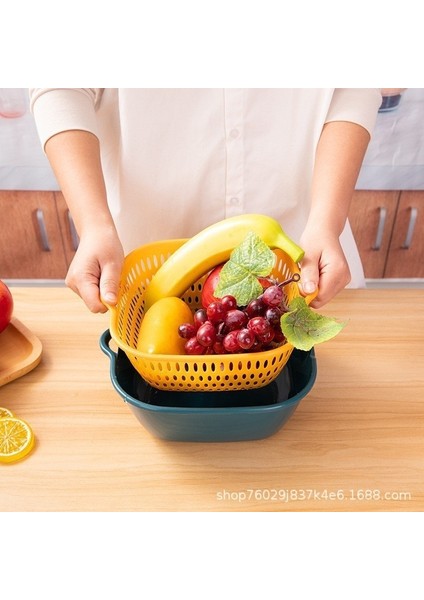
[100,330,317,442]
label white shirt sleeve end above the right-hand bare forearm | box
[325,88,381,135]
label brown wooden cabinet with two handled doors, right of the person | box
[349,190,424,279]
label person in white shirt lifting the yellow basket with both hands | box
[30,88,381,312]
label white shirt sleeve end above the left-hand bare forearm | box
[29,88,103,148]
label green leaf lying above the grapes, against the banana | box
[214,231,276,306]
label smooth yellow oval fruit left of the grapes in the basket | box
[137,296,193,354]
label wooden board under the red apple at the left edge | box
[0,317,42,386]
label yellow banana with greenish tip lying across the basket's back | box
[144,214,303,310]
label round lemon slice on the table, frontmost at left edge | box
[0,417,35,462]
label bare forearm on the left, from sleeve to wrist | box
[45,130,114,236]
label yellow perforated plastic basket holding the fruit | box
[109,239,299,392]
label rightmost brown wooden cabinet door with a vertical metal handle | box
[384,191,424,278]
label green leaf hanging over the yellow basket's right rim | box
[281,296,346,350]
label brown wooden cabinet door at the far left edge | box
[0,191,67,279]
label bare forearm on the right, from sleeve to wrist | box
[306,121,370,236]
